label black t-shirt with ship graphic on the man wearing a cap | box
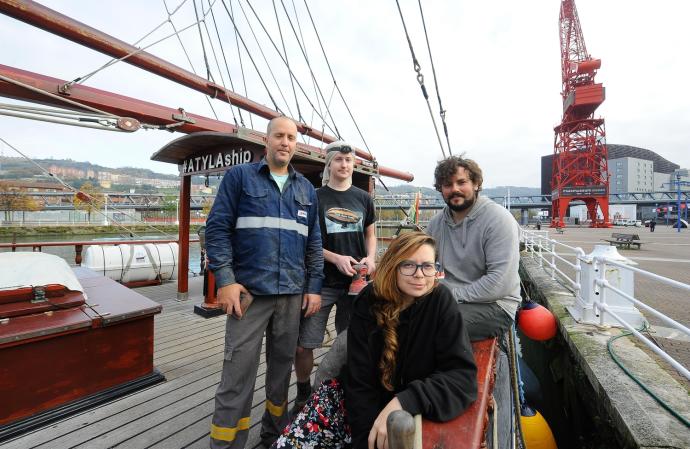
[316,186,376,288]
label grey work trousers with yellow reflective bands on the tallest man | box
[211,294,302,449]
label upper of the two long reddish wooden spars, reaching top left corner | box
[0,0,373,161]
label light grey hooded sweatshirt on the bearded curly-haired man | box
[426,196,522,319]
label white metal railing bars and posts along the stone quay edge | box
[521,228,690,380]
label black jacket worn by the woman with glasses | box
[343,285,477,449]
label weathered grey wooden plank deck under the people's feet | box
[0,277,335,449]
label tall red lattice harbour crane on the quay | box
[551,0,611,228]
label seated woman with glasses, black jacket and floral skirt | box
[274,232,477,449]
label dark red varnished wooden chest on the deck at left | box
[0,267,164,441]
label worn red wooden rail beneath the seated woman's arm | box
[422,338,498,449]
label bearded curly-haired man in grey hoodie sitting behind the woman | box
[426,156,521,341]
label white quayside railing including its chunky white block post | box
[521,229,690,380]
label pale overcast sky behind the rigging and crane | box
[0,0,690,187]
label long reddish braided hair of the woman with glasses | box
[372,232,436,391]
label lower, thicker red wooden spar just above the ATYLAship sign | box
[0,63,414,182]
